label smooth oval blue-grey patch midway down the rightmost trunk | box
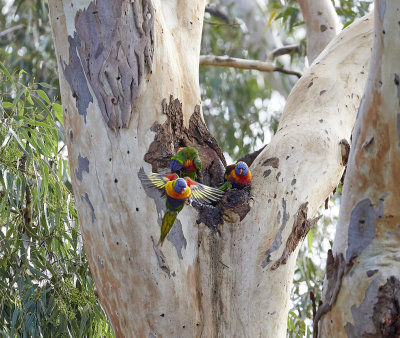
[346,198,377,261]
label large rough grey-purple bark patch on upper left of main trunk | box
[64,0,154,130]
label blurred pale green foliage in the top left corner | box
[0,0,59,98]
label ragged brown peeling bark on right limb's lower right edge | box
[271,202,322,270]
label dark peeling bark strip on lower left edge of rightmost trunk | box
[313,249,348,338]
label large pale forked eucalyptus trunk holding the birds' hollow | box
[49,0,372,337]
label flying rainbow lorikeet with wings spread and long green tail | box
[143,173,224,245]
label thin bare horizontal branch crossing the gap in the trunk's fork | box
[200,55,301,78]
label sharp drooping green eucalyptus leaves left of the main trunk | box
[0,63,112,337]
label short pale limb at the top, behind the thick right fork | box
[297,0,340,64]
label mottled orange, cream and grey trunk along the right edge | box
[319,0,400,337]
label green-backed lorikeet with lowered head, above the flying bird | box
[169,147,201,180]
